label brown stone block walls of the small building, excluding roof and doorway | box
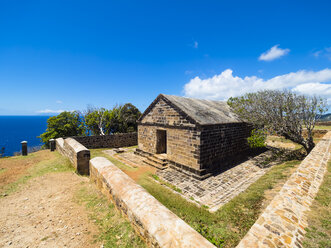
[138,94,251,176]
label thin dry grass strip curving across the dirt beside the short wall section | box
[2,152,74,195]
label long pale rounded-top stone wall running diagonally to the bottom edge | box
[90,157,215,248]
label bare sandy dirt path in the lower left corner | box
[0,172,100,247]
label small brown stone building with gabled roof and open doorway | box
[136,94,251,179]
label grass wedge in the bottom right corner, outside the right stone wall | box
[303,161,331,248]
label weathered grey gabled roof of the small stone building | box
[140,94,242,125]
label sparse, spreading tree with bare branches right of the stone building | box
[228,90,327,154]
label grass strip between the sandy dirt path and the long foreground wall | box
[75,185,146,247]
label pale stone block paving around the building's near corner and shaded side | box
[158,152,269,212]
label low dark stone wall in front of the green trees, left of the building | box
[71,133,138,149]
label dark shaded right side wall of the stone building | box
[199,123,252,170]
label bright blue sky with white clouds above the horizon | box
[0,0,331,115]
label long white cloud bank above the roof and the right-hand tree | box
[184,69,331,101]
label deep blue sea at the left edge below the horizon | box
[0,116,49,156]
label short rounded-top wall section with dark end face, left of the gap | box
[56,138,90,175]
